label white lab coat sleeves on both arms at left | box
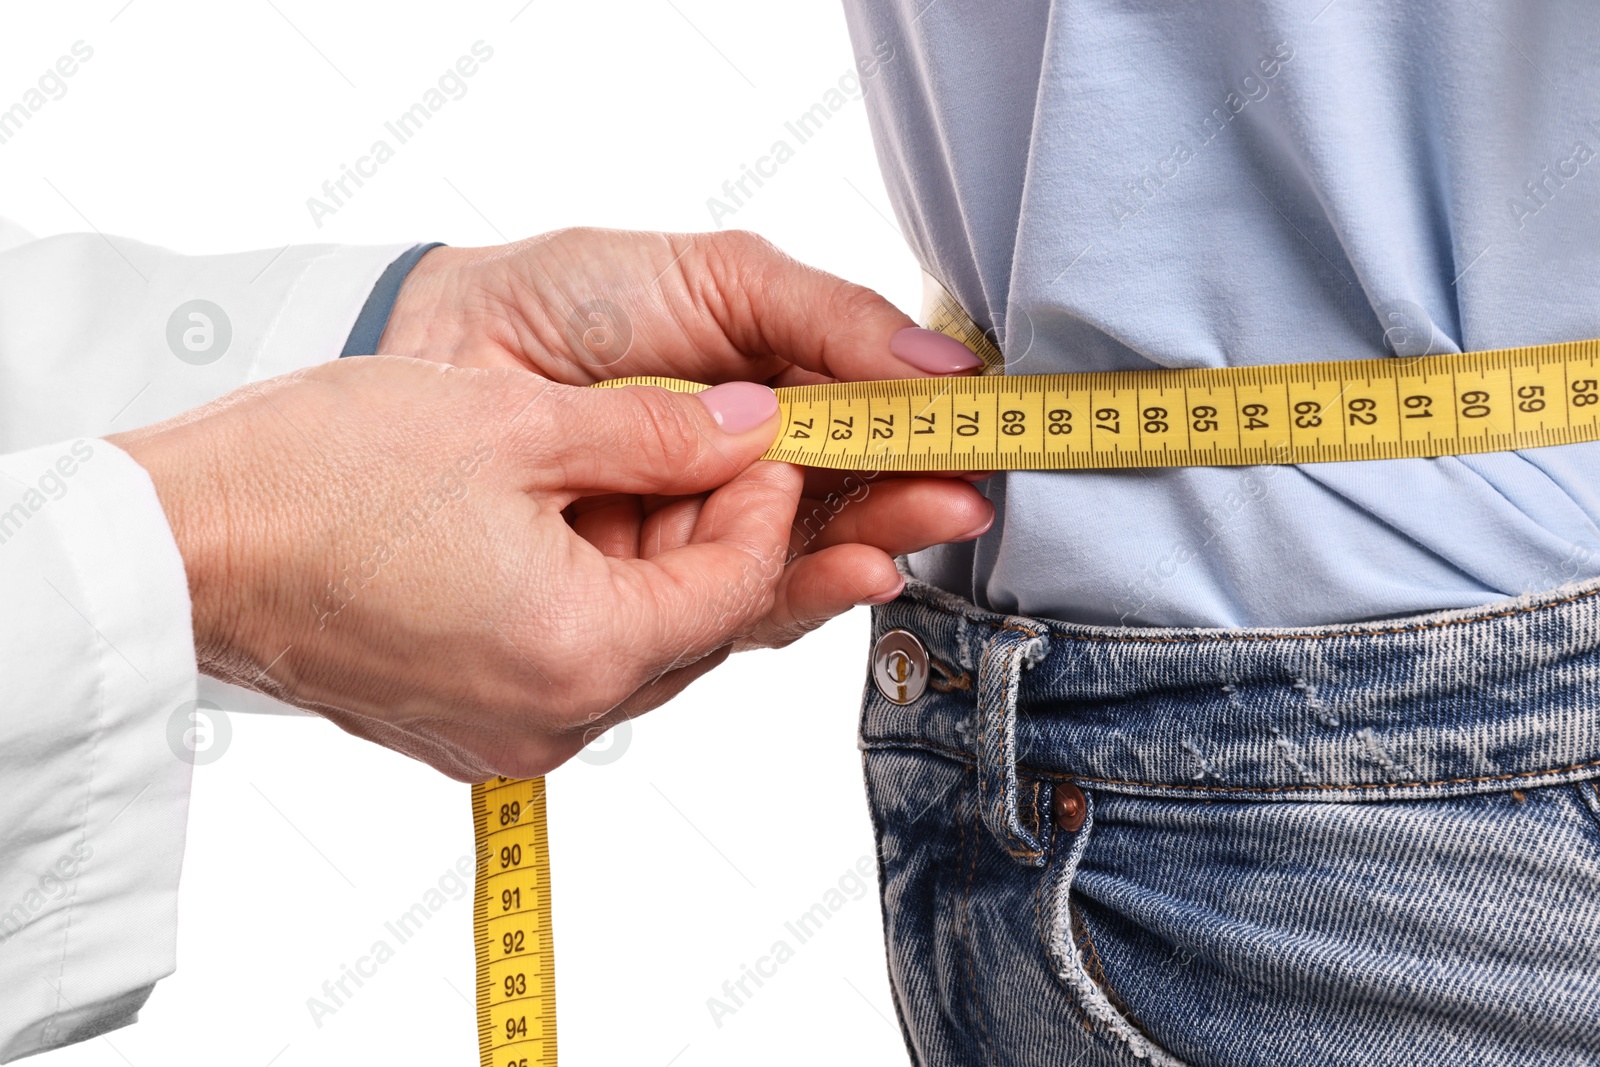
[0,219,408,1062]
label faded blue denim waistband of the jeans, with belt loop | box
[861,579,1600,809]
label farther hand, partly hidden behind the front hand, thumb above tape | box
[379,229,994,630]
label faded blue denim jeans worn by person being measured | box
[861,582,1600,1067]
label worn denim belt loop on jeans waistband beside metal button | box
[978,619,1050,867]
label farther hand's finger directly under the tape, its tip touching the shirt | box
[789,478,995,555]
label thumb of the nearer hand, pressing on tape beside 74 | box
[520,382,781,496]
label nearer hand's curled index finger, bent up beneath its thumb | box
[611,462,802,677]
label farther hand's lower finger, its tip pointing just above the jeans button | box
[734,544,906,651]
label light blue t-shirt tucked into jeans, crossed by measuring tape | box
[845,0,1600,627]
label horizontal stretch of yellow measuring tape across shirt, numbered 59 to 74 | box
[606,341,1600,470]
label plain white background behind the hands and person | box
[0,0,918,1067]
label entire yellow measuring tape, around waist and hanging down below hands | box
[472,287,1600,1067]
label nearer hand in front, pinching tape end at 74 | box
[107,357,802,781]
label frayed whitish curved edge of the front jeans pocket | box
[1043,790,1184,1067]
